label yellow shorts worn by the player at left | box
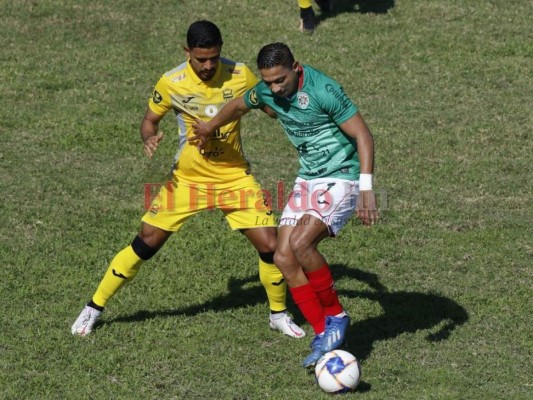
[142,175,276,232]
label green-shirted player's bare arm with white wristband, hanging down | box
[341,113,379,225]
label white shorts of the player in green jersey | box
[279,178,359,236]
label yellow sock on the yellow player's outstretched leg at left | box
[93,246,143,307]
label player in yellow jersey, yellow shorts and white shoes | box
[71,21,305,338]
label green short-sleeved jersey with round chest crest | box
[244,65,359,180]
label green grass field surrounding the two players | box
[0,0,533,400]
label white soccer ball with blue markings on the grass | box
[315,350,361,393]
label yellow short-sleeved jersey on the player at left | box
[148,58,258,187]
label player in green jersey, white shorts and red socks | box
[190,43,378,367]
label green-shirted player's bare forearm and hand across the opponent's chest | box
[188,97,250,148]
